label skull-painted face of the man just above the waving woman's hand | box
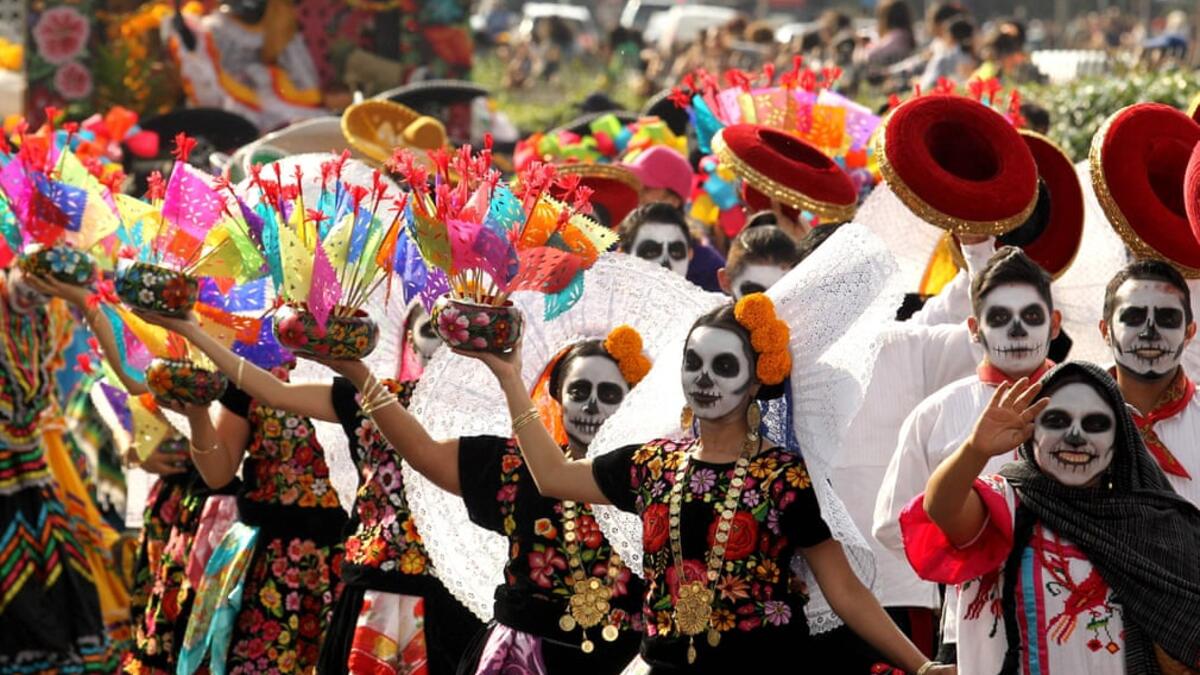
[978,283,1050,376]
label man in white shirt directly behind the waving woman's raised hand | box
[872,246,1061,659]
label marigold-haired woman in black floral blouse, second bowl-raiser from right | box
[333,325,649,675]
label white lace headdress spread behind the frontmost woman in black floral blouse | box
[588,223,902,633]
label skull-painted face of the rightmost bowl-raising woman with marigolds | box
[683,325,752,419]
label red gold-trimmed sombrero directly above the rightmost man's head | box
[1088,103,1200,277]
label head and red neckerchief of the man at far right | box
[1100,261,1200,503]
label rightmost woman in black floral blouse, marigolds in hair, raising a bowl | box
[463,294,953,675]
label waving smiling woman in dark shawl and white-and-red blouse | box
[901,363,1200,675]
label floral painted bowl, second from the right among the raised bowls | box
[275,304,379,360]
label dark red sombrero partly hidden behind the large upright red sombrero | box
[1000,129,1085,279]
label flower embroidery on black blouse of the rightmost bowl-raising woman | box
[630,441,812,637]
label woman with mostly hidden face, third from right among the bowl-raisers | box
[136,307,481,675]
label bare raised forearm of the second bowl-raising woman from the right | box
[322,360,462,495]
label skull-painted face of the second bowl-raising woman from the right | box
[562,356,629,449]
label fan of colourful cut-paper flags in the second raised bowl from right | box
[240,153,409,329]
